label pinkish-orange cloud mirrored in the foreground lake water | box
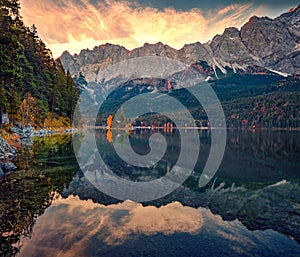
[20,196,203,256]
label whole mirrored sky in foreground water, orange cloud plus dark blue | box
[19,193,300,257]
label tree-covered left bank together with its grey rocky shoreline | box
[0,0,80,176]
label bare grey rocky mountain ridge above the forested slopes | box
[60,5,300,82]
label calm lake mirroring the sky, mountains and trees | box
[0,130,300,257]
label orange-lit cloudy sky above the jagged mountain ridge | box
[21,0,299,58]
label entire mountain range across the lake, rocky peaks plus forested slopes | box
[60,5,300,128]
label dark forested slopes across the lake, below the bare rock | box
[97,74,300,128]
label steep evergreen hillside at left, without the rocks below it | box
[0,0,79,127]
